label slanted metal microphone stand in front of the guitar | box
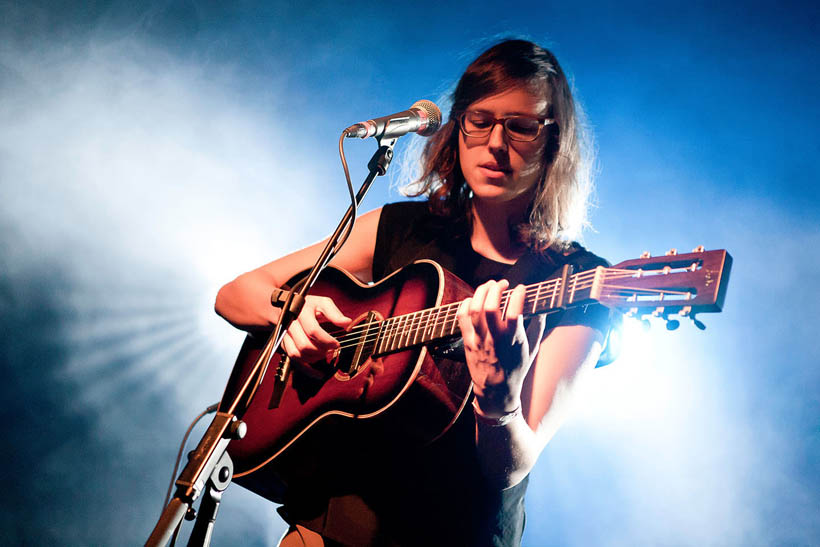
[145,137,404,547]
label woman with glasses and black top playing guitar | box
[216,40,608,545]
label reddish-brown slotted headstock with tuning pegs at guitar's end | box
[595,247,732,324]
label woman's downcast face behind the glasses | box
[458,85,549,210]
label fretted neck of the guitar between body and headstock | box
[368,265,606,354]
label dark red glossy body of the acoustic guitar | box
[221,260,473,501]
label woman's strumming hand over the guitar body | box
[282,295,352,365]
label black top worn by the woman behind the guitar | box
[280,202,608,547]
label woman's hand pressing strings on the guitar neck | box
[458,280,545,417]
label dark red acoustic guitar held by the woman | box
[216,247,732,501]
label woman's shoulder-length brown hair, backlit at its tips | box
[408,40,592,252]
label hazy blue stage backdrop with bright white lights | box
[0,0,820,546]
